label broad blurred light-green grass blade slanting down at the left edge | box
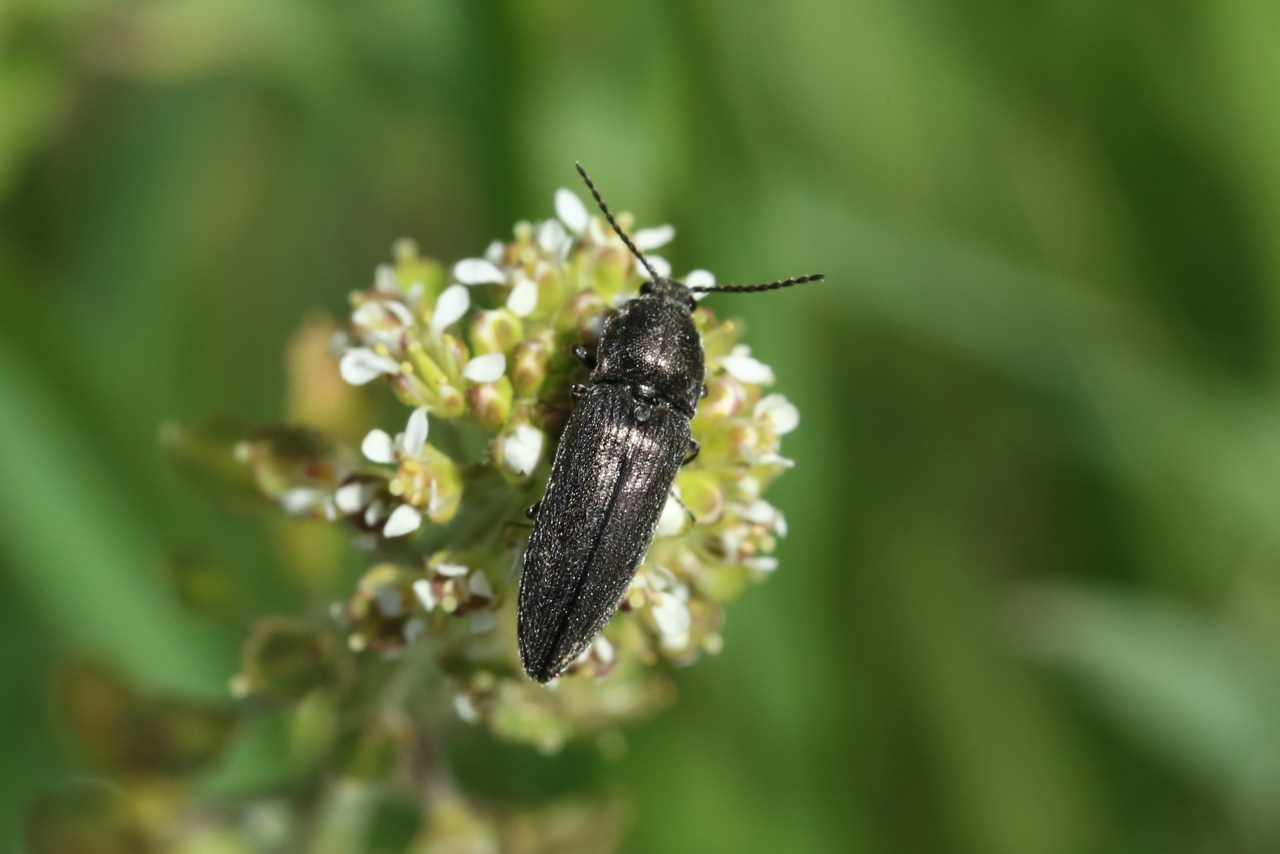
[0,346,229,694]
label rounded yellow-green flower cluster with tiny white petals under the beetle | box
[225,189,799,750]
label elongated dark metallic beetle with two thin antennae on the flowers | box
[517,163,823,682]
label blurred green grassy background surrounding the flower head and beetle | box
[0,0,1280,854]
